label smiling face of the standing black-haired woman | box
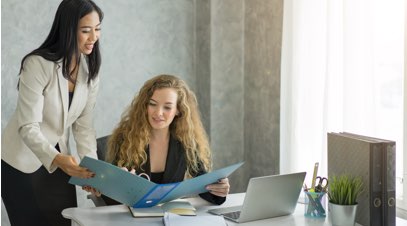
[78,11,100,55]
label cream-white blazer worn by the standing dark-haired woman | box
[1,56,99,173]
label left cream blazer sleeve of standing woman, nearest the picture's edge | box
[17,56,59,172]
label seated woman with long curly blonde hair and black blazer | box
[105,75,230,204]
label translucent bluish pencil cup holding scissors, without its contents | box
[304,191,326,218]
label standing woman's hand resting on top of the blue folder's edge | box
[52,154,95,178]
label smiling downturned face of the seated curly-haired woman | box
[147,88,178,130]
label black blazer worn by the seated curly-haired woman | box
[102,136,226,205]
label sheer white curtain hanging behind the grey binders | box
[280,0,406,201]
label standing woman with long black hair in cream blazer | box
[1,0,103,226]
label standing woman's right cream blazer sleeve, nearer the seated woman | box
[72,76,99,159]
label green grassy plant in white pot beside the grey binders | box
[328,174,363,225]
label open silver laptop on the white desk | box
[208,172,306,223]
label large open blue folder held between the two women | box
[69,157,243,208]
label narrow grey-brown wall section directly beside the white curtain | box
[244,0,283,178]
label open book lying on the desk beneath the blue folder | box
[129,199,196,217]
